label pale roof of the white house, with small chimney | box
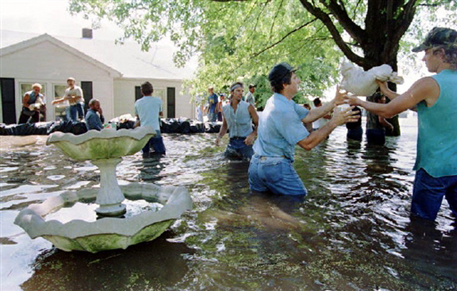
[0,30,196,80]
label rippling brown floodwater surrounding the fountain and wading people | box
[0,120,457,290]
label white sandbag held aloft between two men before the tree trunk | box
[340,62,403,96]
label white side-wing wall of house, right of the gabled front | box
[114,79,195,119]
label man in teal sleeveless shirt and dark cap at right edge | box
[348,27,457,220]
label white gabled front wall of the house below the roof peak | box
[0,41,115,121]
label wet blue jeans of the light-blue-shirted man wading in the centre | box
[248,155,308,195]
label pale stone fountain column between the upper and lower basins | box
[92,158,126,216]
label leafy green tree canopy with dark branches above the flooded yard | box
[70,0,456,107]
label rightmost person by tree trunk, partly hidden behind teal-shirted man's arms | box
[366,92,394,145]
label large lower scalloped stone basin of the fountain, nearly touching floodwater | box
[14,183,192,253]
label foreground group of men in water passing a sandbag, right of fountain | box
[216,28,457,224]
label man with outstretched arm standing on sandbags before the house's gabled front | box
[52,77,84,121]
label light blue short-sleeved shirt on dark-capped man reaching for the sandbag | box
[254,93,309,160]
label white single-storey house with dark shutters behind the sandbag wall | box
[0,29,195,124]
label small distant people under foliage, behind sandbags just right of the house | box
[197,84,256,122]
